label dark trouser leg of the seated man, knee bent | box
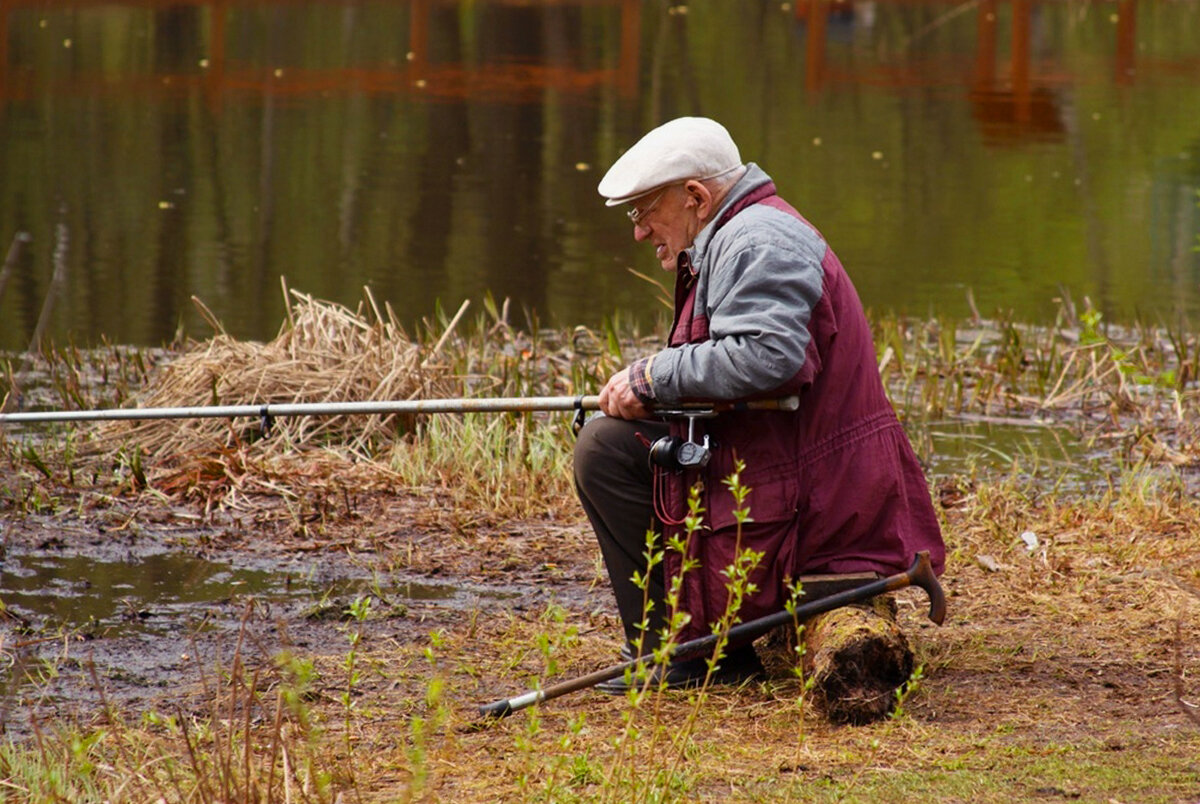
[575,416,667,654]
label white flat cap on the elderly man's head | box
[596,118,742,206]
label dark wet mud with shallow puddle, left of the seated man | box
[0,544,525,734]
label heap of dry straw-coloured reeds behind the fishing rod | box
[92,286,455,491]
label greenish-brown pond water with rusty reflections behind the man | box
[0,0,1200,349]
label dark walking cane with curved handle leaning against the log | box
[479,550,946,718]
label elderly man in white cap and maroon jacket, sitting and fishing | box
[575,118,944,692]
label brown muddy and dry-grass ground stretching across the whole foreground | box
[0,475,1200,804]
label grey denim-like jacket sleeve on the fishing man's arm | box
[650,217,826,404]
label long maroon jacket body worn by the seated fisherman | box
[653,166,946,640]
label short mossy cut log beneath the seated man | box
[756,580,913,725]
